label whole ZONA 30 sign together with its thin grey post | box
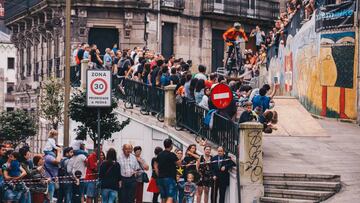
[86,70,111,202]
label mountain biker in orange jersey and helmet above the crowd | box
[223,22,248,70]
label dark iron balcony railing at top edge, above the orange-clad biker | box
[202,0,279,20]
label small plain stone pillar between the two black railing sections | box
[164,85,176,126]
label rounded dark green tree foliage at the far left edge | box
[0,110,37,145]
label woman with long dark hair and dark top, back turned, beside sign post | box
[99,148,121,203]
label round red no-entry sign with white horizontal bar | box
[210,84,233,109]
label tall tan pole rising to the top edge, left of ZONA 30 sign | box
[64,0,71,146]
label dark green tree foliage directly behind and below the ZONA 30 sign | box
[69,91,130,145]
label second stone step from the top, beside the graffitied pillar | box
[264,180,341,192]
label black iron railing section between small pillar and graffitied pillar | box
[176,100,239,154]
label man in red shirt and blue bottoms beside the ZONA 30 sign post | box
[85,145,102,203]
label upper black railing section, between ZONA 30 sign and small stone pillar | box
[113,77,165,122]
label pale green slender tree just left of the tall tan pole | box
[40,78,64,129]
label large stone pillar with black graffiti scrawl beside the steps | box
[239,122,264,202]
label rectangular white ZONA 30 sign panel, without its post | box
[86,70,111,107]
